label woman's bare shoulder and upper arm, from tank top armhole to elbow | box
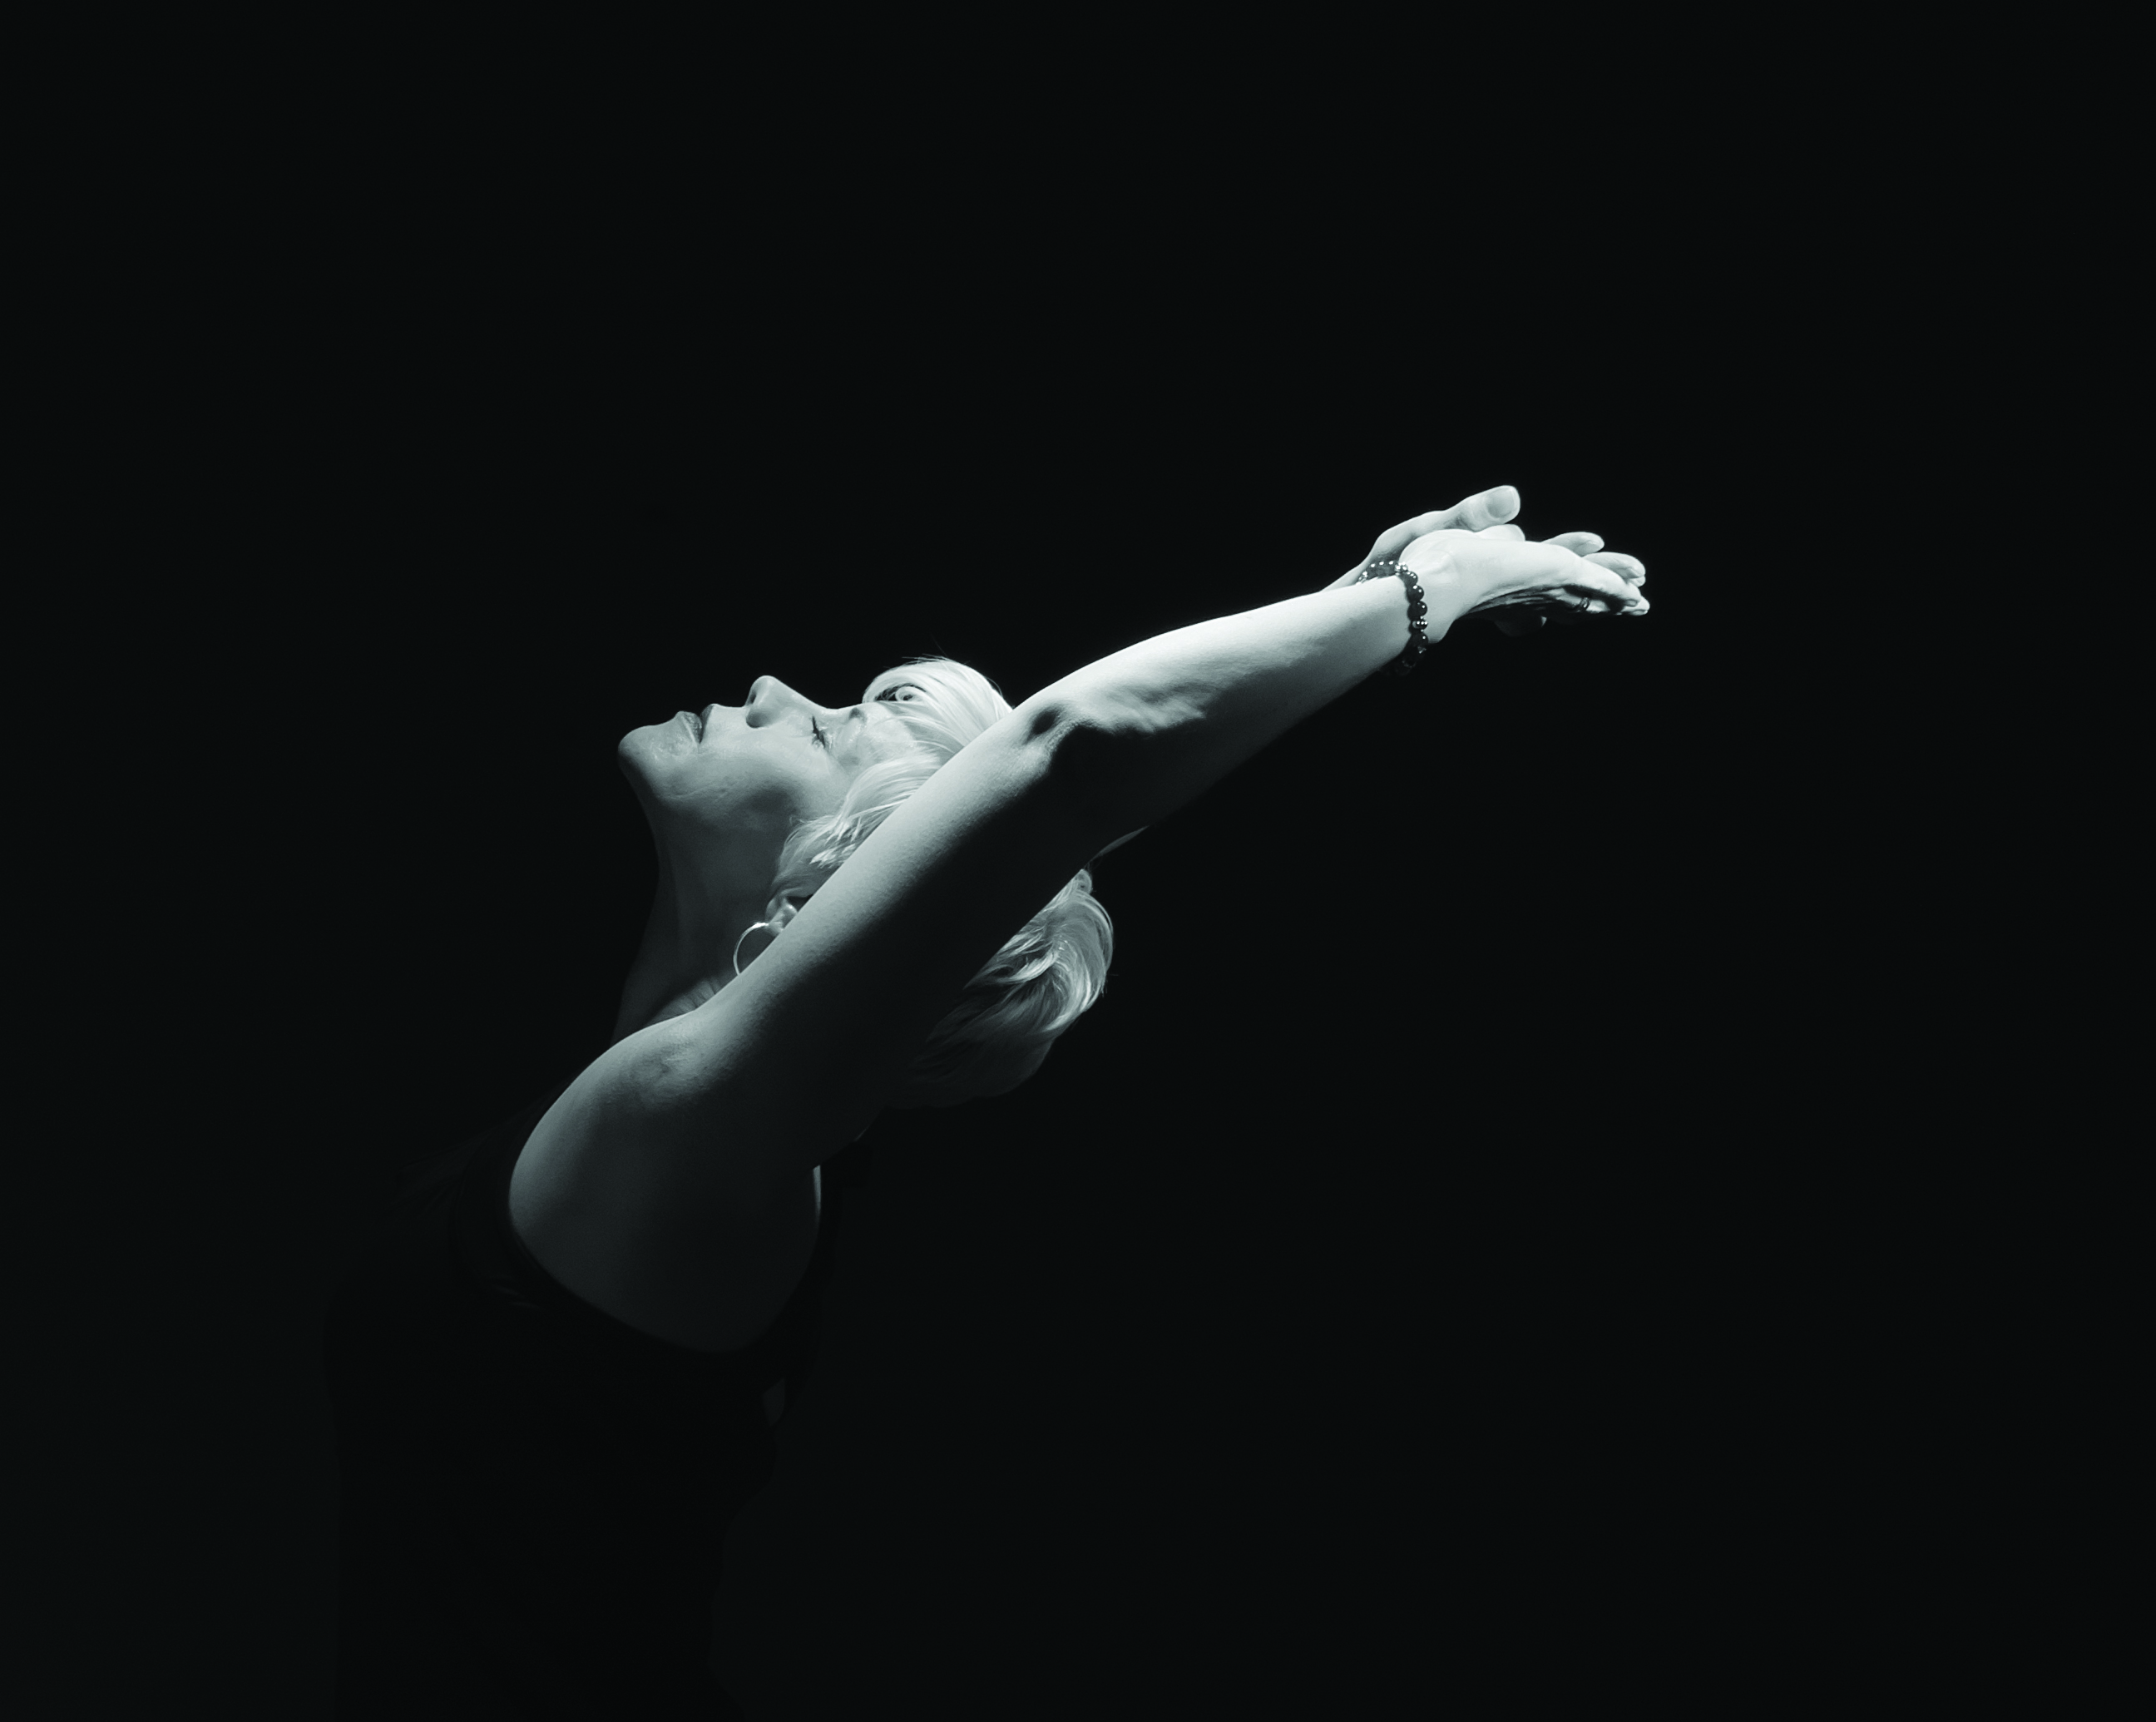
[509,696,1128,1343]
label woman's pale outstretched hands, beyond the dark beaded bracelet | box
[1333,485,1647,634]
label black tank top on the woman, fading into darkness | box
[324,1073,867,1722]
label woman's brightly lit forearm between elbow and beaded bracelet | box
[1033,576,1453,829]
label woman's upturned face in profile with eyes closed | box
[615,676,912,933]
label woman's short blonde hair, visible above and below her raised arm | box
[772,657,1115,1108]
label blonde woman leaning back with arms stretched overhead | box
[325,487,1647,1718]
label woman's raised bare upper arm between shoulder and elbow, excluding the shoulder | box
[621,700,1119,1203]
